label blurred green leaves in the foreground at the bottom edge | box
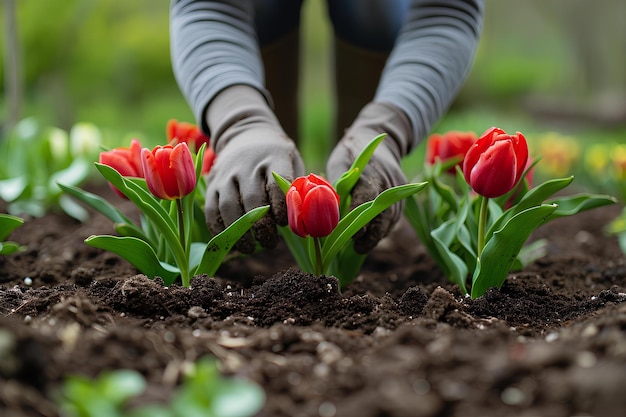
[59,358,265,417]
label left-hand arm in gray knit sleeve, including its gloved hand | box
[170,0,304,253]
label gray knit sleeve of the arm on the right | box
[374,0,484,149]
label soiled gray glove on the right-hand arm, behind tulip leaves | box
[326,103,412,253]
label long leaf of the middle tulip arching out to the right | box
[322,182,427,271]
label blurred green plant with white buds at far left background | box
[0,118,101,221]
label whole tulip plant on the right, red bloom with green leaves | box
[405,128,616,298]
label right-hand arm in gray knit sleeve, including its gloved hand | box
[326,0,484,253]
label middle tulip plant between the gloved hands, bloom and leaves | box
[273,134,426,287]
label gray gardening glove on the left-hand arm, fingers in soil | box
[205,85,304,253]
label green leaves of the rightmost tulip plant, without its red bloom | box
[405,161,616,298]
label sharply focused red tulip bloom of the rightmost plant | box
[463,127,528,198]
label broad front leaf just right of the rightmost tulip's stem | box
[471,204,557,298]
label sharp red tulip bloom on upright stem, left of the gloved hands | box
[141,142,196,200]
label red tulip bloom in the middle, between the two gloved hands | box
[286,174,339,237]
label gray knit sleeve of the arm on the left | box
[170,0,269,133]
